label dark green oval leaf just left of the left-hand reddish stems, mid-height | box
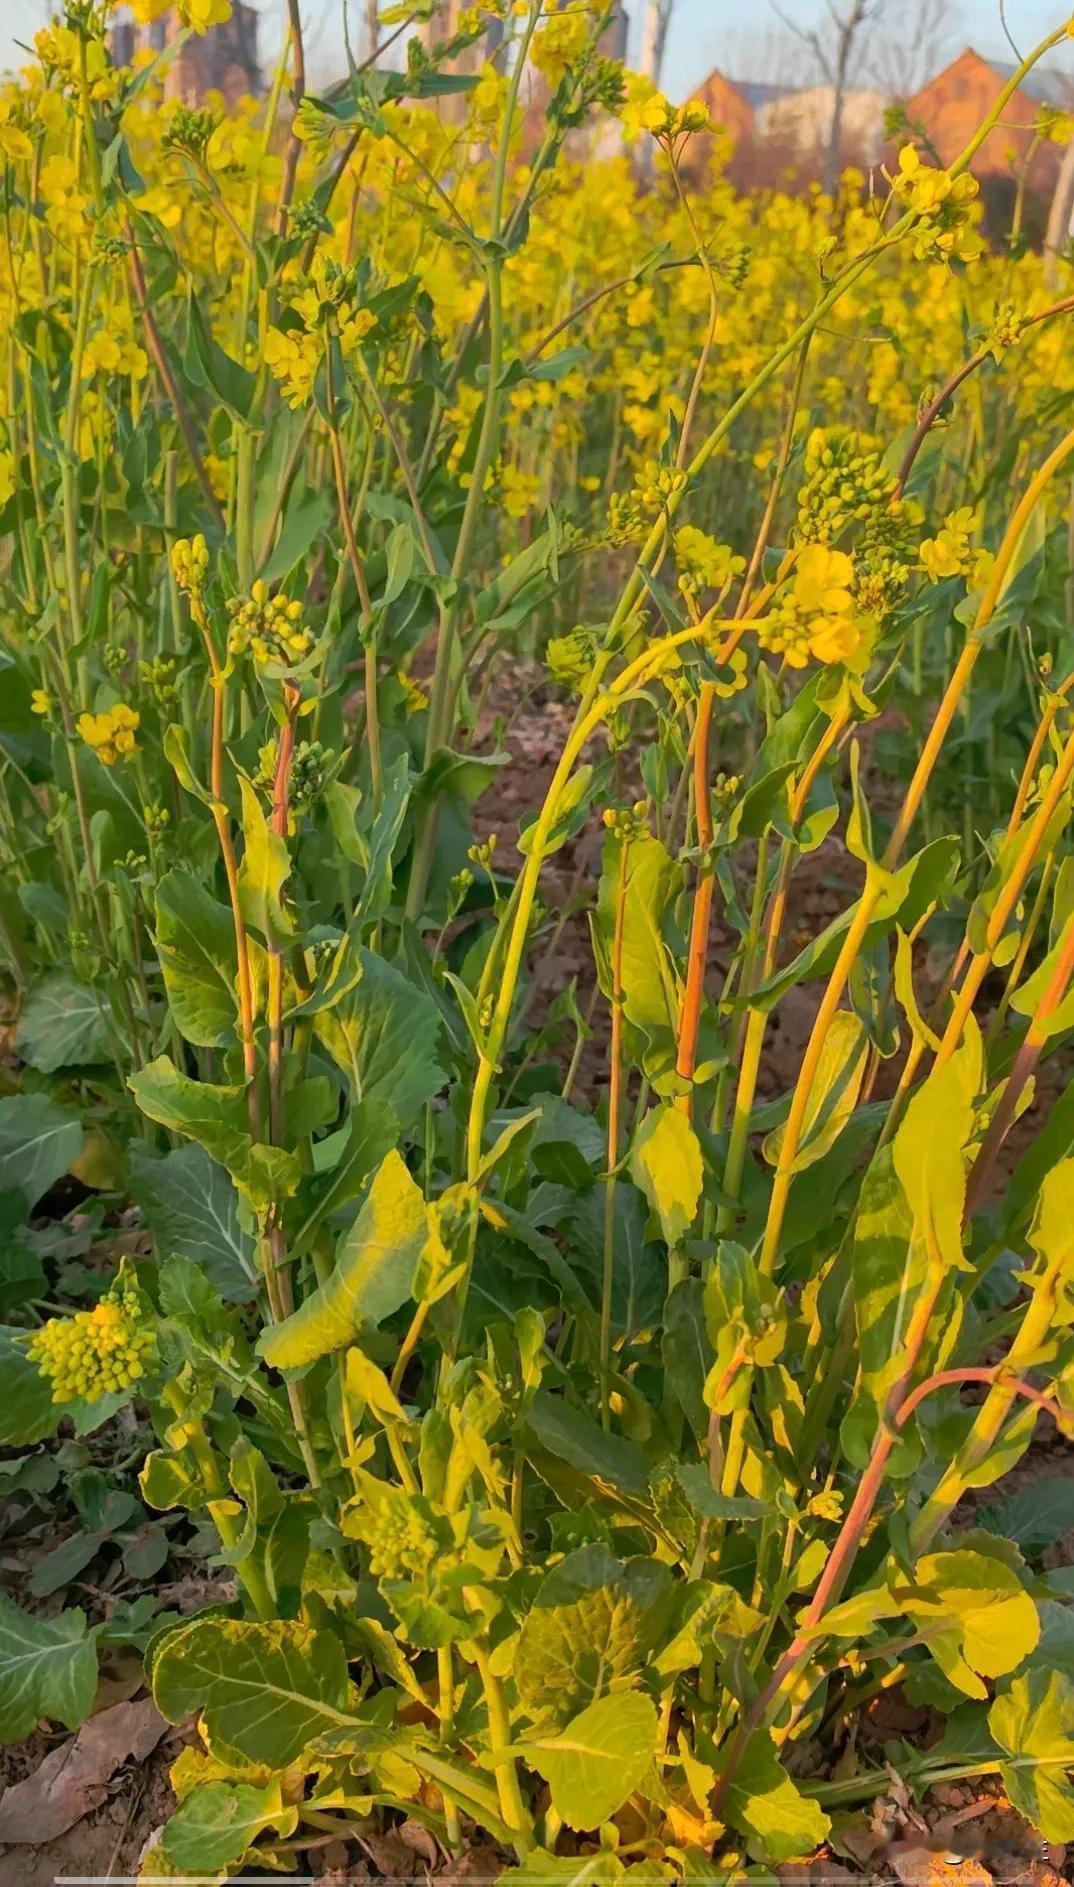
[157,872,238,1049]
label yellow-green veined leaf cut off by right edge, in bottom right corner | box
[989,1670,1074,1842]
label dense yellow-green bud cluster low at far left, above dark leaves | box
[26,1277,157,1402]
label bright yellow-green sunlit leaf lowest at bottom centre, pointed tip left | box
[527,1691,657,1829]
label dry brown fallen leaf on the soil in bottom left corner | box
[0,1696,168,1845]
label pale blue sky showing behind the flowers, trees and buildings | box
[0,0,1070,98]
